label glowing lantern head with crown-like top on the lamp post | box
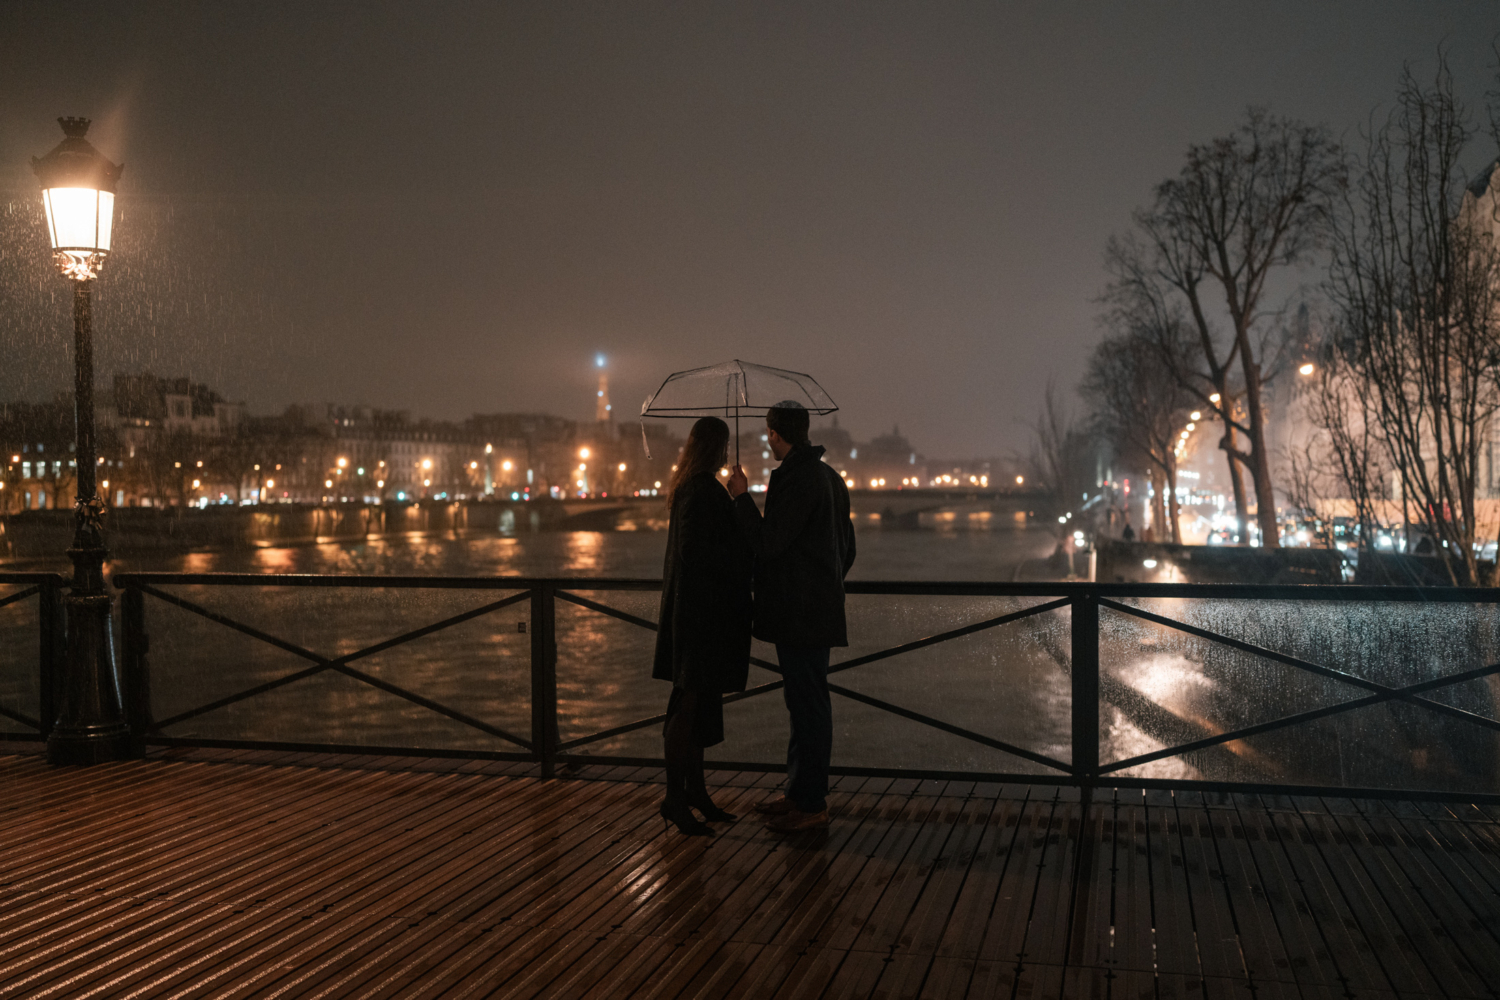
[32,118,125,282]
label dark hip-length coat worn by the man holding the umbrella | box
[735,445,854,648]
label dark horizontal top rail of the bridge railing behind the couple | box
[111,573,1500,604]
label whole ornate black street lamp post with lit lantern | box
[32,118,131,765]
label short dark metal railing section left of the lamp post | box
[0,573,68,741]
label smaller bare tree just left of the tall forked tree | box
[1082,316,1193,544]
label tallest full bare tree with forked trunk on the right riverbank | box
[1116,108,1344,546]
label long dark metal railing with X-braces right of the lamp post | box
[0,573,1500,802]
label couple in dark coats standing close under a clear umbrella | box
[651,402,854,837]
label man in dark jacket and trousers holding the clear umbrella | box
[729,400,854,834]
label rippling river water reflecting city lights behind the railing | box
[0,526,1500,789]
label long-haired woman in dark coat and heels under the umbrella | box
[651,417,750,837]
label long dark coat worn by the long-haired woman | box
[651,472,752,694]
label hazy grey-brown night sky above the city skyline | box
[0,0,1500,457]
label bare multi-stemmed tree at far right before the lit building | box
[1325,60,1500,582]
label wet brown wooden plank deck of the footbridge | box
[0,751,1500,1000]
